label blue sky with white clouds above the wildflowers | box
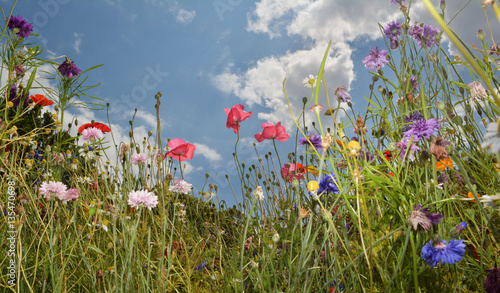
[2,0,494,202]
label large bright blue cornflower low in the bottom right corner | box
[422,239,465,267]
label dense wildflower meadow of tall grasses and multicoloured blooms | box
[0,0,500,293]
